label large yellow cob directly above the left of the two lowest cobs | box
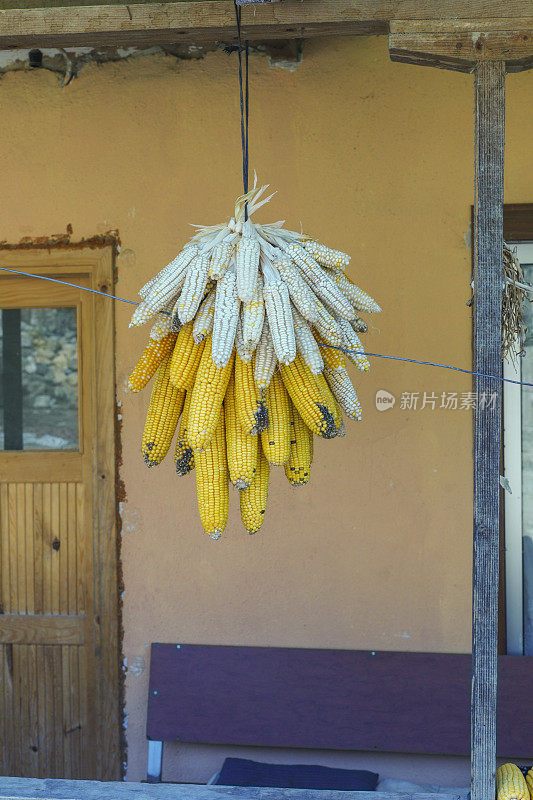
[188,334,234,450]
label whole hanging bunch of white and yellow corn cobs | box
[129,184,381,539]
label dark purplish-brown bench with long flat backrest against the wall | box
[143,644,533,782]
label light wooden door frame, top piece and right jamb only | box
[0,242,123,780]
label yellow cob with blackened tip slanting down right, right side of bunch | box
[281,354,337,439]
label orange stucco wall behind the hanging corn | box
[0,38,533,783]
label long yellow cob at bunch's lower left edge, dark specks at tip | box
[142,355,185,467]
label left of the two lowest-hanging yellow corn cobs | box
[195,414,229,539]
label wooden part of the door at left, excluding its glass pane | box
[0,251,121,780]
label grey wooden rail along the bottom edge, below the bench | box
[0,778,470,800]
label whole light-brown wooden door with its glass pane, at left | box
[0,248,121,780]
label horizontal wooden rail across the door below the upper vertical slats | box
[0,614,85,645]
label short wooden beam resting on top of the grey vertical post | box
[389,18,533,72]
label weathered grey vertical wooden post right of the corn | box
[471,61,505,800]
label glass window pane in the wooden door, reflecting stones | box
[0,308,78,450]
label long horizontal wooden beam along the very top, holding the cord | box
[0,0,533,48]
